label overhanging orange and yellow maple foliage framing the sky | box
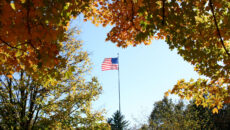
[0,0,230,112]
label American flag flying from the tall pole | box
[101,58,118,71]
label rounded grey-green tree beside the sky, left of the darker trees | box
[149,97,185,129]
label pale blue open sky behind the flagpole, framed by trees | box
[72,17,199,127]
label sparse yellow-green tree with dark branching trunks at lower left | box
[0,30,109,130]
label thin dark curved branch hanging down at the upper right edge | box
[209,0,230,56]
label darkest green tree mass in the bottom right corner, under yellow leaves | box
[185,101,230,130]
